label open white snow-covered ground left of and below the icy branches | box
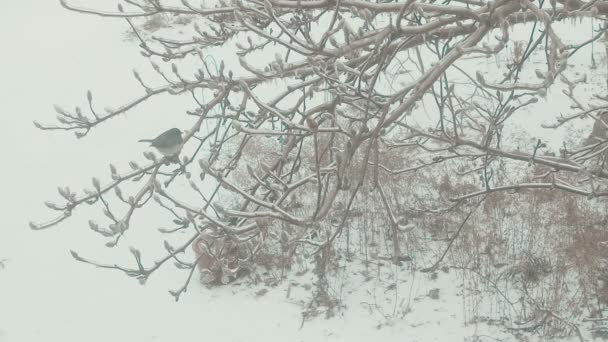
[0,0,604,342]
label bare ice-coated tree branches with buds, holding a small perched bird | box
[31,0,608,297]
